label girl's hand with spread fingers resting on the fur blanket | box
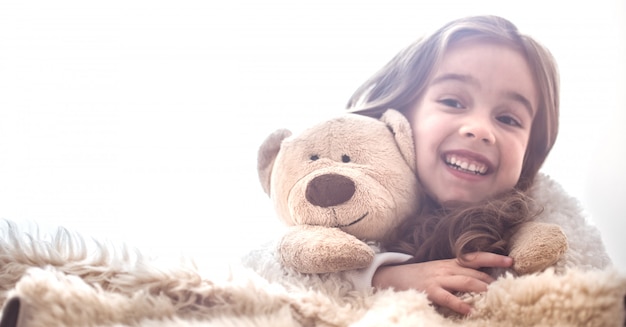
[372,252,513,315]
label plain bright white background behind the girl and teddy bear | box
[0,0,626,269]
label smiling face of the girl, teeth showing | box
[407,42,538,203]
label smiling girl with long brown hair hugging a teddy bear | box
[348,16,609,314]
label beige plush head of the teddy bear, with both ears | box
[258,110,421,240]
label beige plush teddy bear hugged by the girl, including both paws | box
[257,109,567,274]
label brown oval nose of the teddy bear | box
[306,174,355,208]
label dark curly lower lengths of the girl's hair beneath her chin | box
[382,190,540,262]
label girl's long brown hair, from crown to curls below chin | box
[348,16,559,261]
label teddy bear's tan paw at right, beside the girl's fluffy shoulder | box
[509,222,568,275]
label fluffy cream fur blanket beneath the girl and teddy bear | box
[0,174,626,327]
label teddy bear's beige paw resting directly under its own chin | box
[277,225,374,274]
